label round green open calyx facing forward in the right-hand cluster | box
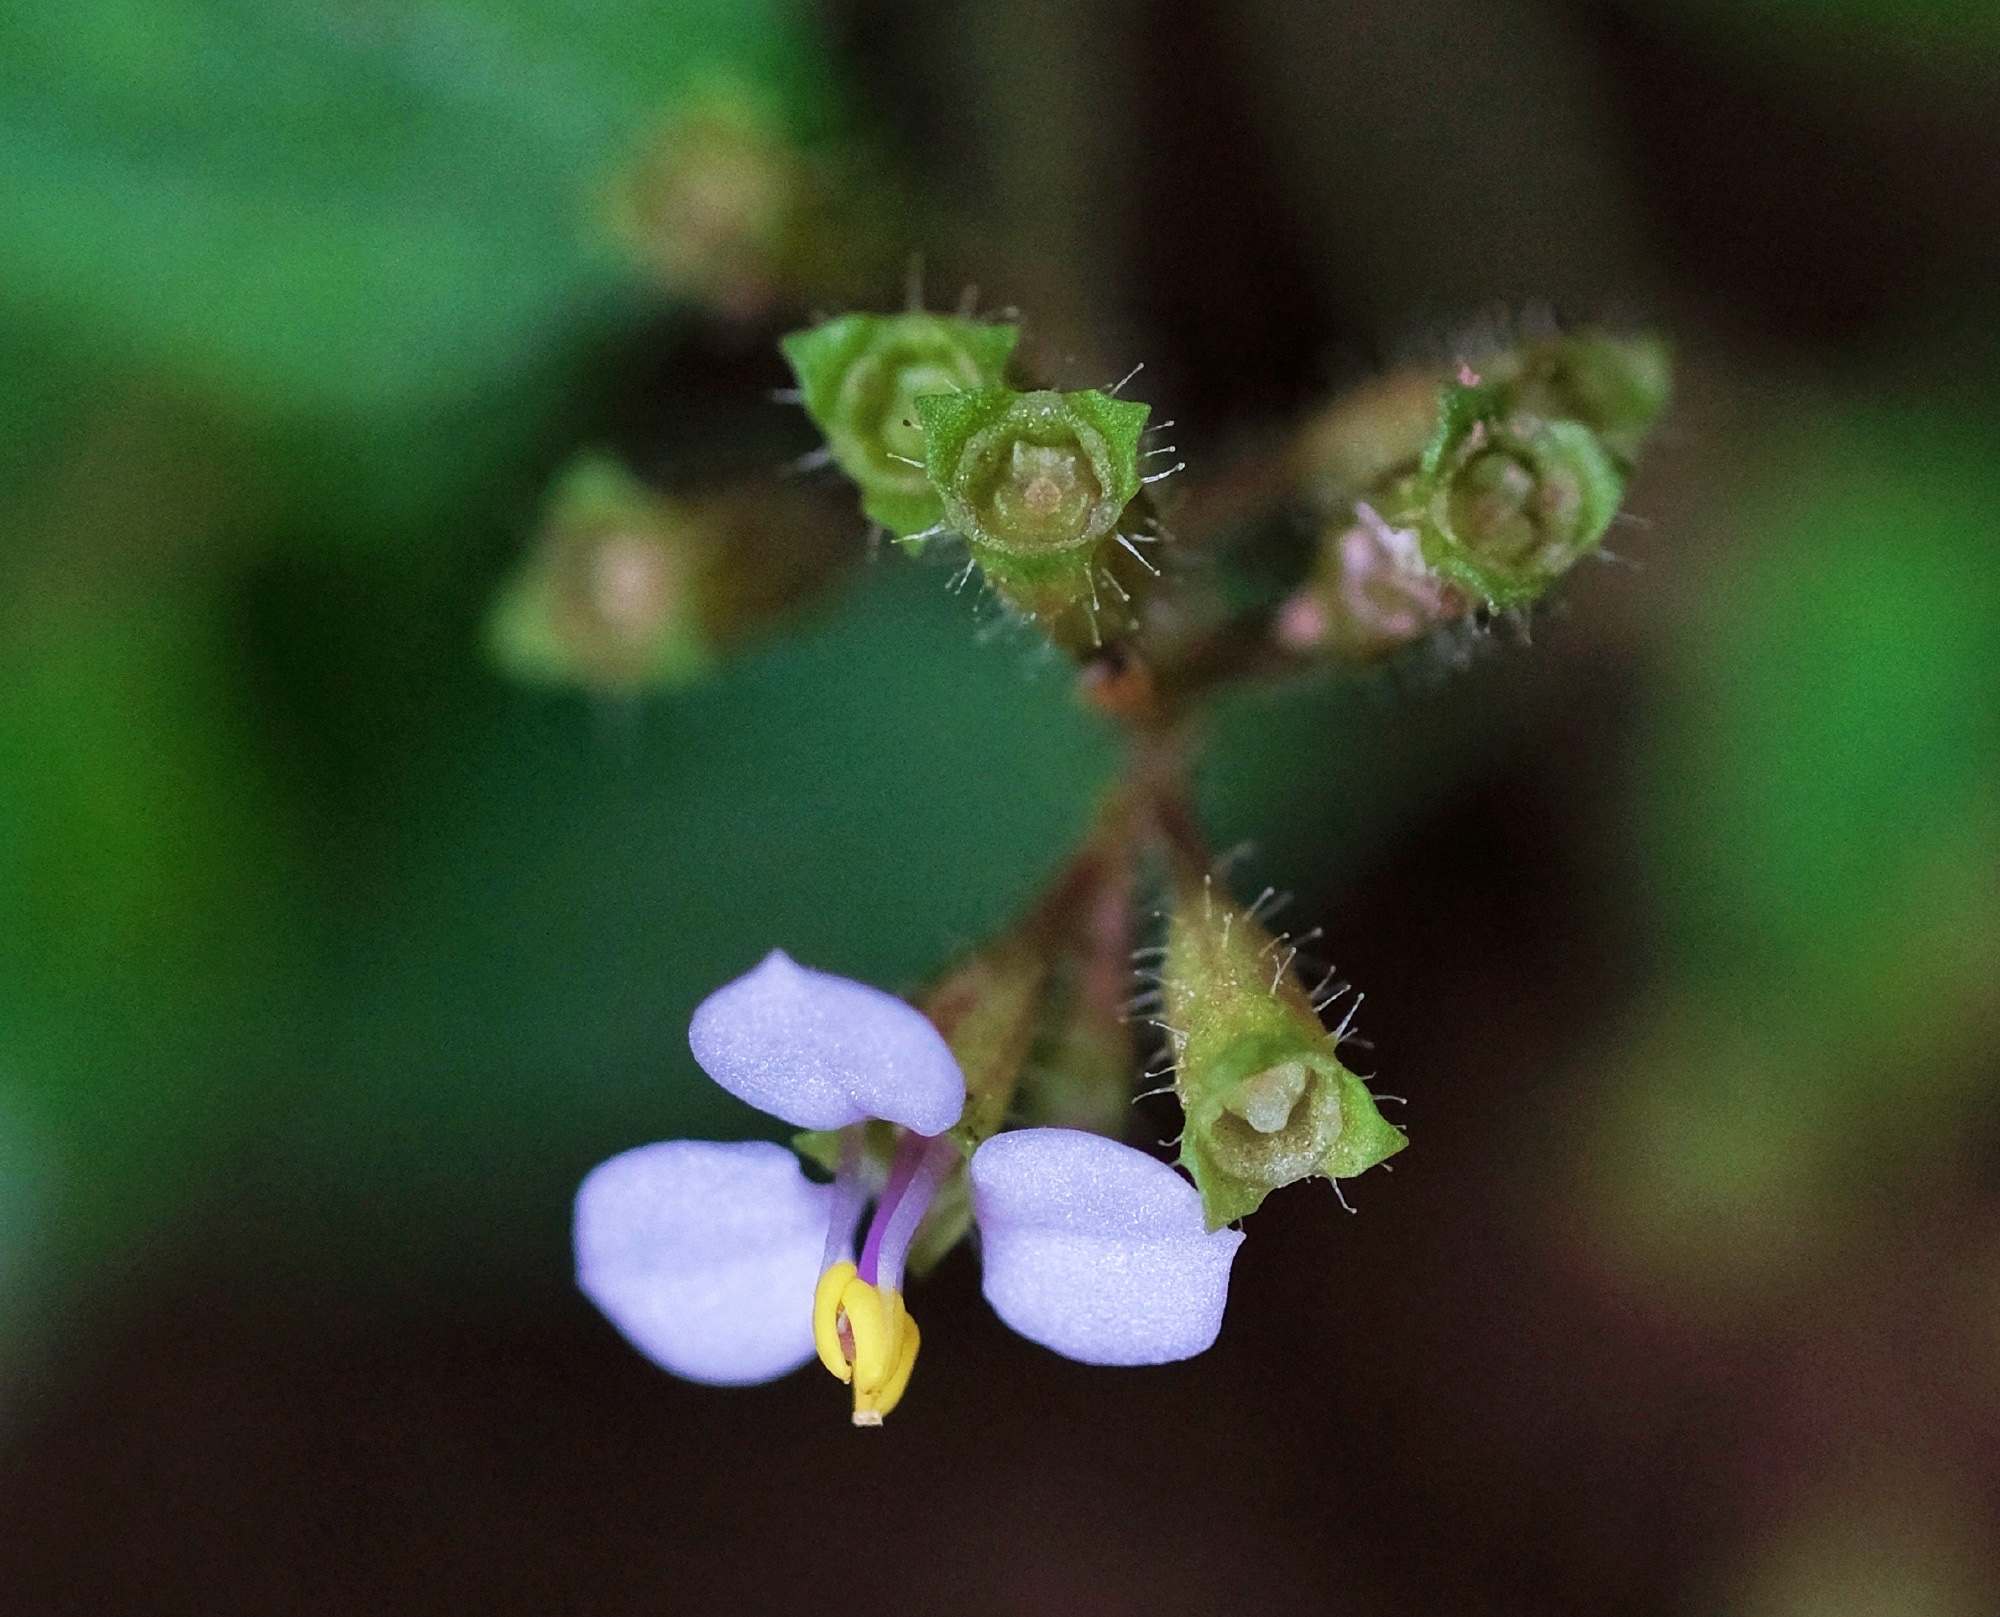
[1402,382,1624,606]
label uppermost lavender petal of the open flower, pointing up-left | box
[688,949,966,1136]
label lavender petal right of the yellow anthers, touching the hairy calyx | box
[972,1129,1242,1365]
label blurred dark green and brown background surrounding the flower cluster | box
[0,0,2000,1617]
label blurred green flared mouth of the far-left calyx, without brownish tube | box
[486,454,716,690]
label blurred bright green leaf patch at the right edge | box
[1644,410,2000,1011]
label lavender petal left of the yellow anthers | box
[576,1141,834,1387]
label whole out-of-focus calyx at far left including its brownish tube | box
[486,456,852,692]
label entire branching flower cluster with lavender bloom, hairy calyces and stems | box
[556,296,1668,1425]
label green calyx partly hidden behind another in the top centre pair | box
[780,312,1020,538]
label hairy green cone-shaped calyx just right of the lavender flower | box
[1162,875,1408,1229]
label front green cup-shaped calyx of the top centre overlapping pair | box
[918,386,1154,644]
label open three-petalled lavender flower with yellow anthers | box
[576,951,1242,1425]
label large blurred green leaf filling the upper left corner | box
[0,0,826,414]
